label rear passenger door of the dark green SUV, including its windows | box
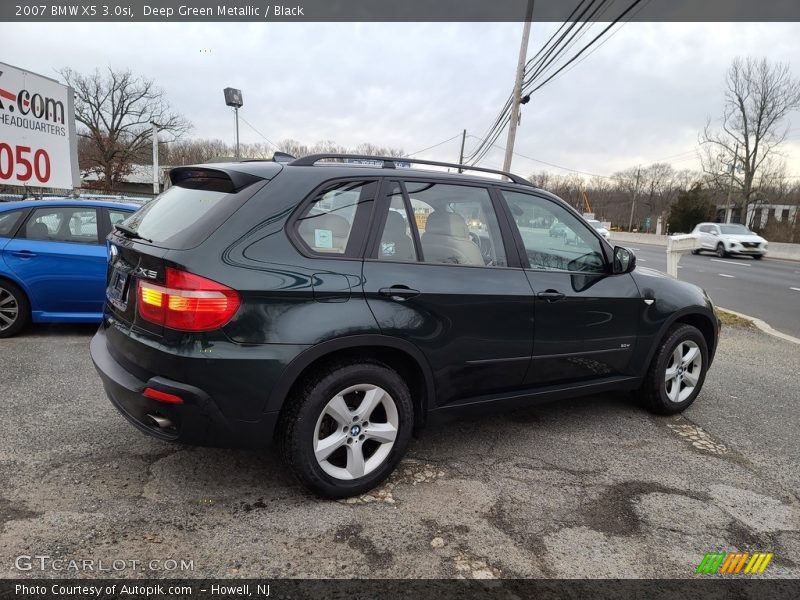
[363,180,533,405]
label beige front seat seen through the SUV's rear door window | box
[422,210,485,266]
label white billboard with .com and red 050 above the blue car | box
[0,62,80,189]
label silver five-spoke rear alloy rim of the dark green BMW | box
[313,383,400,480]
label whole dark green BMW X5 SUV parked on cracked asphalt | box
[91,155,719,497]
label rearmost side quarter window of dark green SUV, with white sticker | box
[295,181,377,256]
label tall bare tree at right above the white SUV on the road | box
[700,57,800,223]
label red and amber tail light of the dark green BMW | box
[136,267,241,331]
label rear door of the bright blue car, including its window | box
[4,205,106,317]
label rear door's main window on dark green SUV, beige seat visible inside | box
[405,181,508,267]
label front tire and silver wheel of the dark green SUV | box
[638,323,708,415]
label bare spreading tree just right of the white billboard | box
[59,67,192,190]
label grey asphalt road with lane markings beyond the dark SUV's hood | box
[621,243,800,338]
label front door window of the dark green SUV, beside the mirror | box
[503,191,606,273]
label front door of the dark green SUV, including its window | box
[502,191,643,386]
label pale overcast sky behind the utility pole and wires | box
[2,23,800,176]
